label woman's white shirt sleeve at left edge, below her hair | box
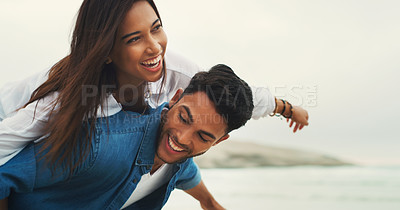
[0,93,57,166]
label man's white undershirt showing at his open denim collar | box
[121,164,174,209]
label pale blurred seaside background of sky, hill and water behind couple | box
[0,0,400,210]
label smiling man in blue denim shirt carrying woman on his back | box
[0,65,254,209]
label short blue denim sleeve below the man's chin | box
[176,158,201,190]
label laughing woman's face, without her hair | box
[109,1,167,85]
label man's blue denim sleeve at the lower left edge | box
[0,143,36,199]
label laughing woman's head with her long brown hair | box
[1,0,166,174]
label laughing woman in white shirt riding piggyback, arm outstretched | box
[0,0,308,173]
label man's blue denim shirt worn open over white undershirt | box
[0,104,201,210]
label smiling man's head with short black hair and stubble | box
[155,65,253,167]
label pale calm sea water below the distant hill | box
[163,166,400,210]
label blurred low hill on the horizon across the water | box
[195,140,351,168]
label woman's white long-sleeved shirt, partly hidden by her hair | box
[0,50,275,166]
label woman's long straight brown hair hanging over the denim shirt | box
[25,0,165,175]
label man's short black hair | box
[183,64,254,133]
